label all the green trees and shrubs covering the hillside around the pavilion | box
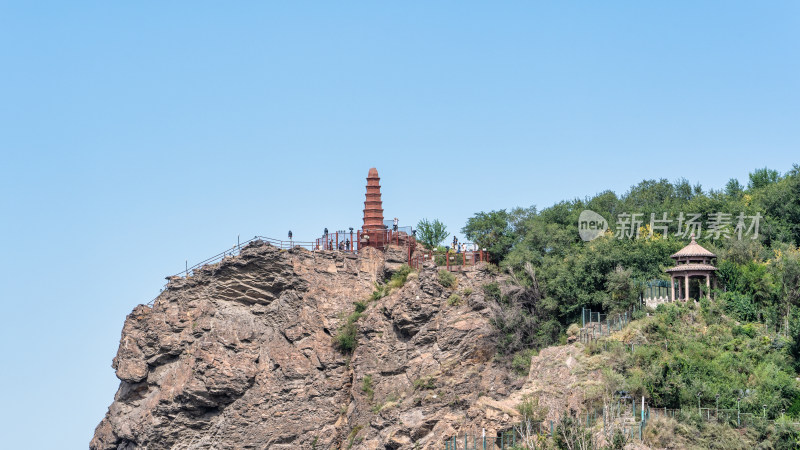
[462,165,800,448]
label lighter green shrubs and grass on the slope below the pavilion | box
[585,301,800,449]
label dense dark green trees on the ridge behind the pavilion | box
[462,165,800,354]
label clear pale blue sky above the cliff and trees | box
[0,1,800,448]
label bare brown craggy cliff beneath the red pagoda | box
[90,242,525,450]
